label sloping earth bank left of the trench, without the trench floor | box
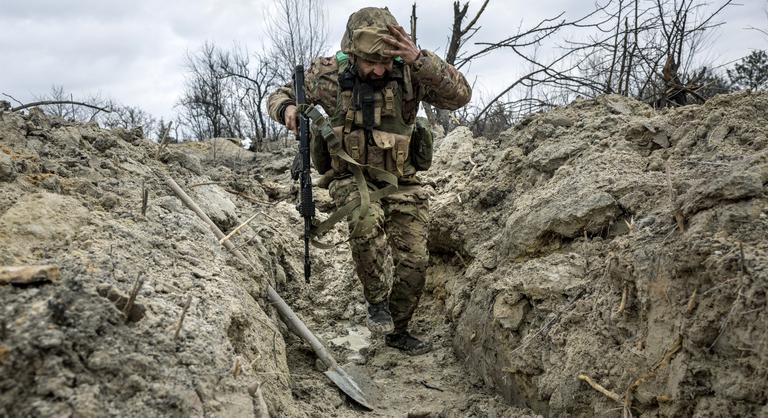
[0,111,301,416]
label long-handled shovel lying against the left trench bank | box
[162,173,373,410]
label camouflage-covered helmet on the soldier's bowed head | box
[341,7,398,62]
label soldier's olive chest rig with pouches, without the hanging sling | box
[330,52,414,184]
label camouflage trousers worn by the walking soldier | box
[329,178,429,331]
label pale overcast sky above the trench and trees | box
[0,0,768,118]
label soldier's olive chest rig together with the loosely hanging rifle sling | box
[300,52,416,249]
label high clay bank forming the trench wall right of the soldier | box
[430,92,768,416]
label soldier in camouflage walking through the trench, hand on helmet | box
[268,7,472,355]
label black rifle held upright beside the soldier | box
[293,65,315,283]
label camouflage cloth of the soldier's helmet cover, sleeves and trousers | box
[268,8,471,331]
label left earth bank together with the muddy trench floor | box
[0,110,531,417]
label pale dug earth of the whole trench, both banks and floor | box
[0,93,768,417]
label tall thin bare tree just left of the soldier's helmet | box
[267,0,328,83]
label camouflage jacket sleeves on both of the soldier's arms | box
[267,50,472,124]
